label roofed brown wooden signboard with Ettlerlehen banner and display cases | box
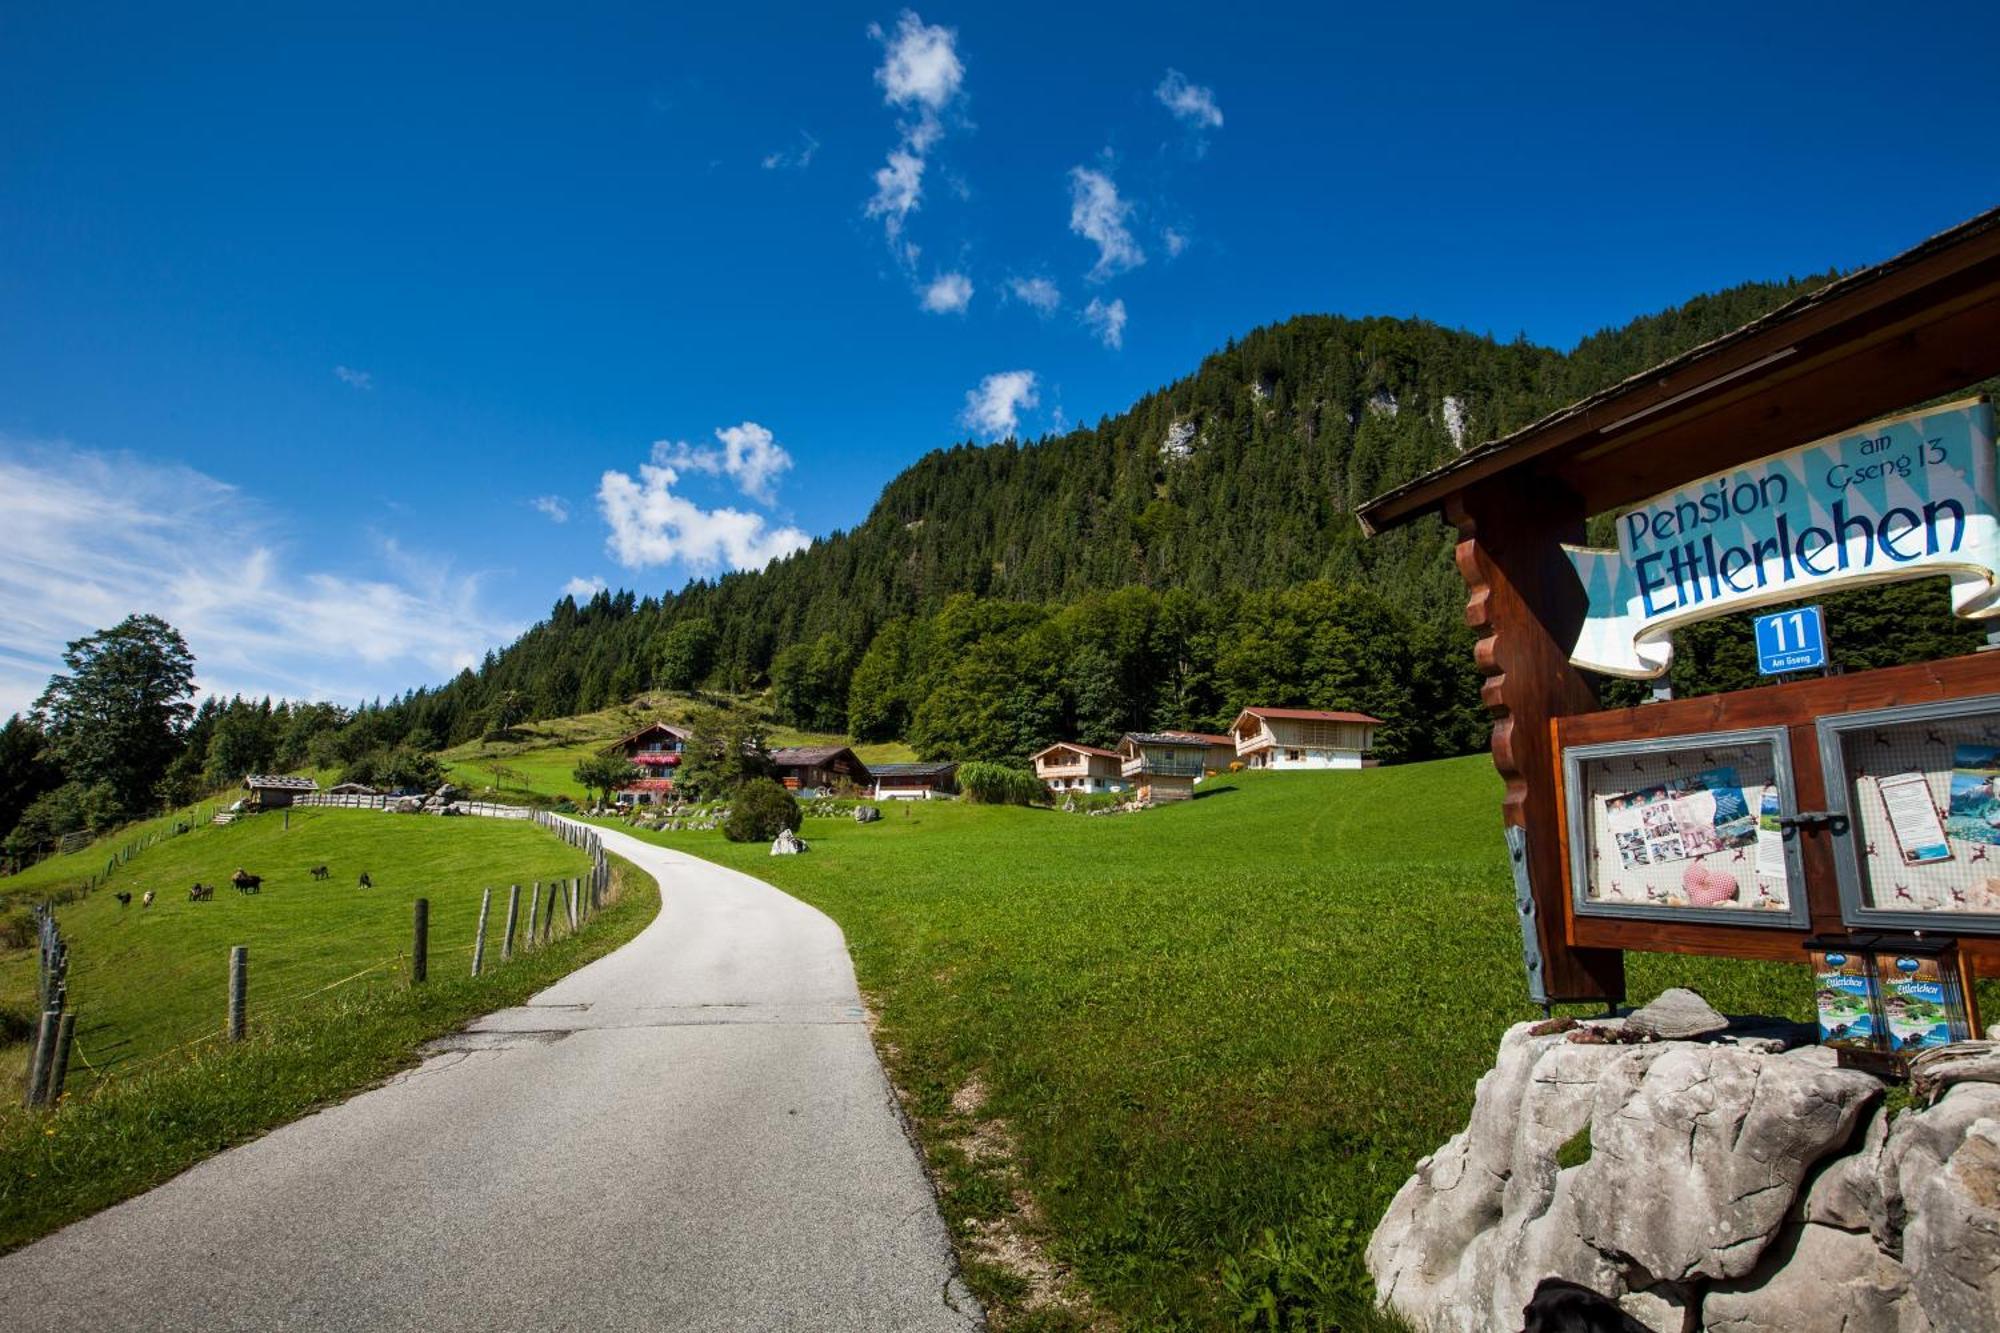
[1360,210,2000,1003]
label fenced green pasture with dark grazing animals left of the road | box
[0,809,586,1093]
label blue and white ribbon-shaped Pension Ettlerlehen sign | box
[1566,398,2000,679]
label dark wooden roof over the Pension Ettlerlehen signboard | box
[1358,208,2000,534]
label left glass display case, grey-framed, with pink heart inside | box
[1562,727,1808,929]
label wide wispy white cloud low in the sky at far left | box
[0,438,524,717]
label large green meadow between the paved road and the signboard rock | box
[608,757,1810,1329]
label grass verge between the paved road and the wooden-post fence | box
[0,844,660,1253]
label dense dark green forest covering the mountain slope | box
[15,274,1994,851]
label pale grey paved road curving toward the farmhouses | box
[0,833,980,1333]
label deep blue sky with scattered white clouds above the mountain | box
[0,4,2000,713]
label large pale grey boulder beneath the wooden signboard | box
[1368,1021,2000,1333]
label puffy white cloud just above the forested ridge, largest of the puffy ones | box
[598,462,808,570]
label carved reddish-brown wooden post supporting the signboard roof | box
[1444,480,1624,1005]
